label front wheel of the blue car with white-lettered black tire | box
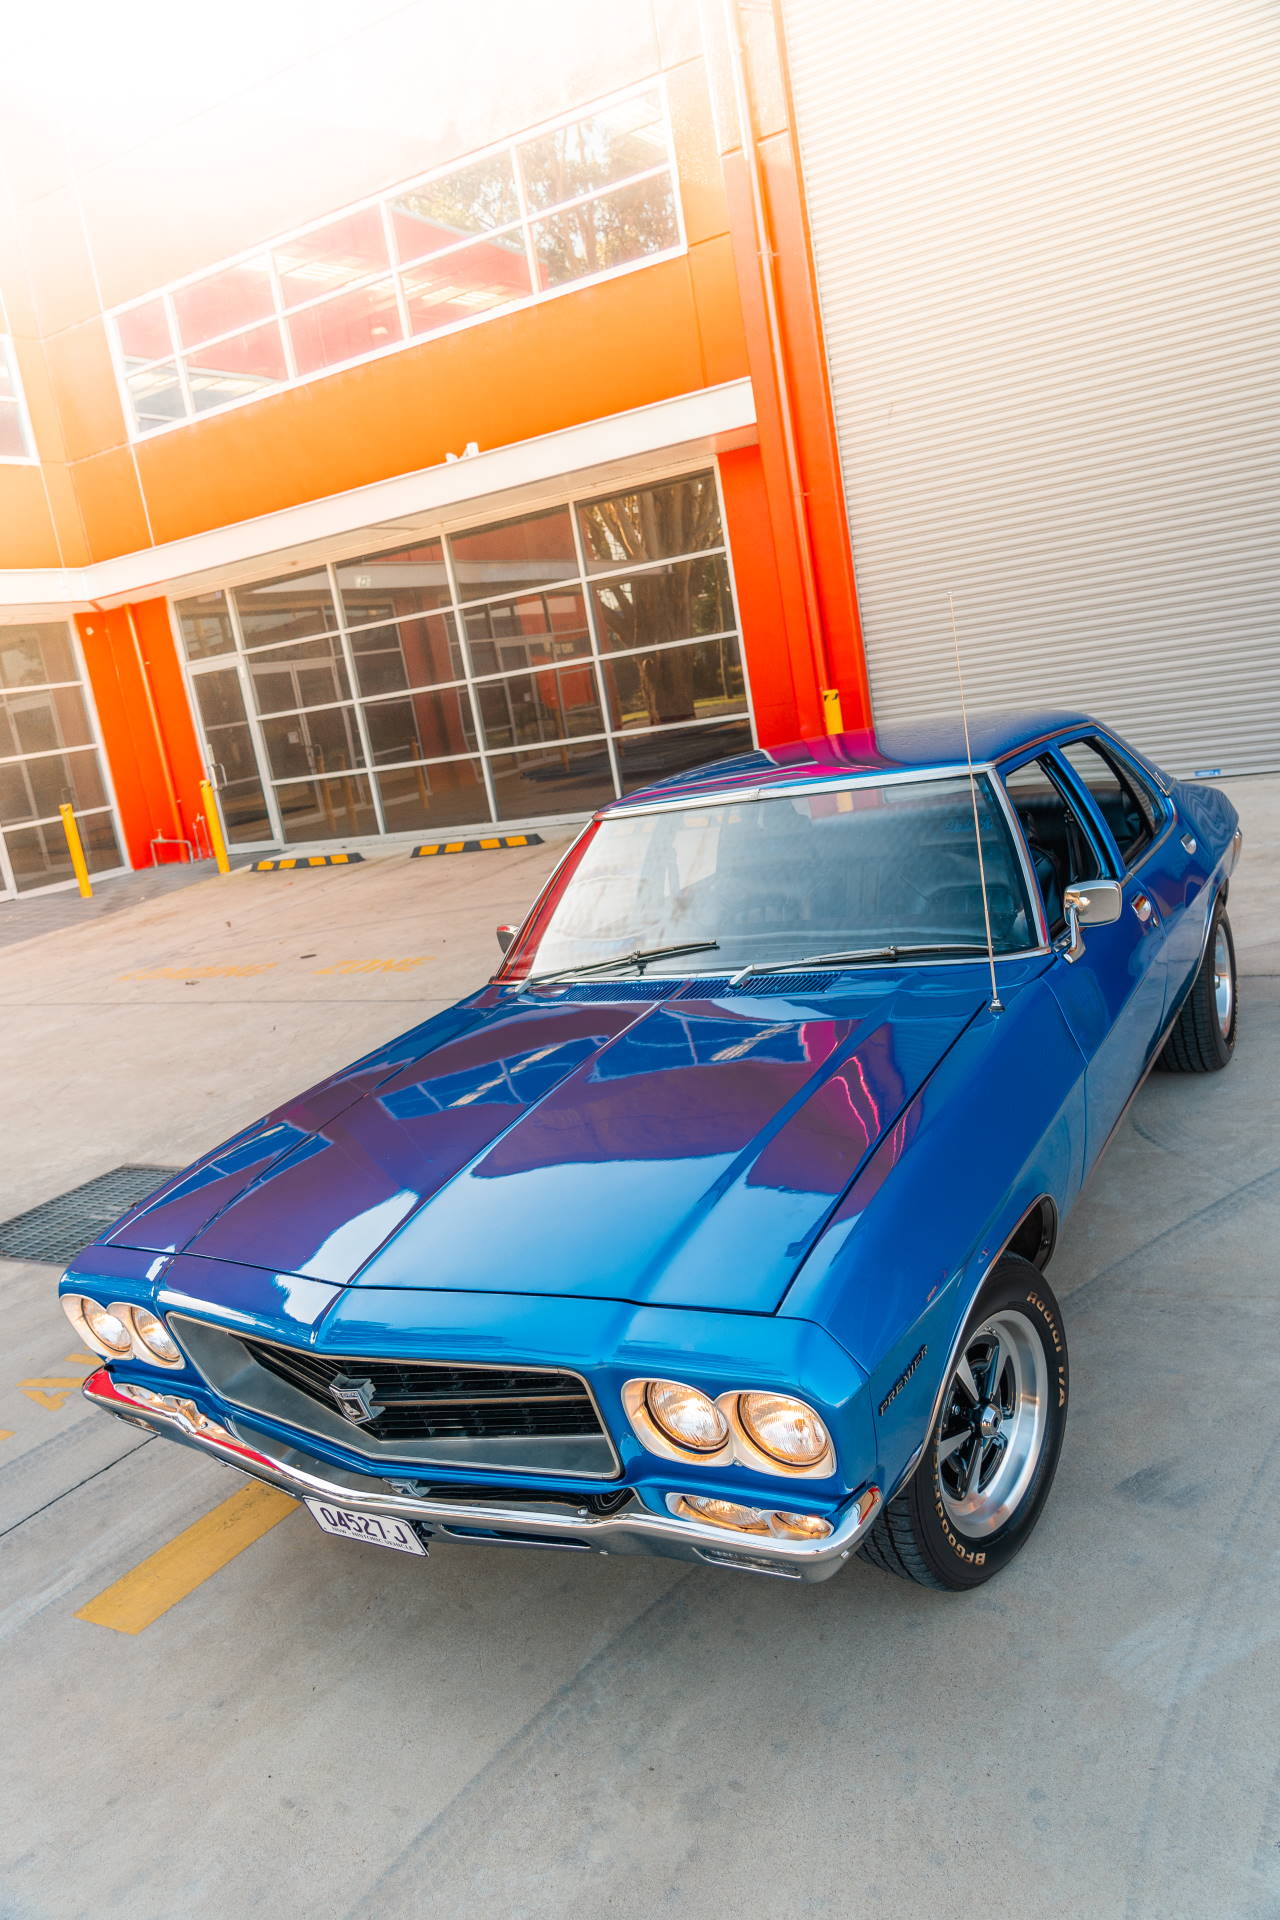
[860,1254,1069,1592]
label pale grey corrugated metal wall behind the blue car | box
[783,0,1280,772]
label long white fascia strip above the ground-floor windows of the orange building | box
[0,380,756,622]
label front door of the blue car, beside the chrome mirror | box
[1004,751,1165,1160]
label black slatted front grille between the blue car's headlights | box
[240,1338,601,1442]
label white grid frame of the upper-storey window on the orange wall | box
[106,75,689,442]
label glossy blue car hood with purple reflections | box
[107,968,984,1313]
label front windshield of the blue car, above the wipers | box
[509,774,1038,977]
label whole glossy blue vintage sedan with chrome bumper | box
[61,712,1240,1590]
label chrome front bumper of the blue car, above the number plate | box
[83,1367,883,1580]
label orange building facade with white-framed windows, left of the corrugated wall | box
[0,0,869,899]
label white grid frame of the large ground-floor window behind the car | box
[169,455,758,852]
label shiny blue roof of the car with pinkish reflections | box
[601,708,1098,814]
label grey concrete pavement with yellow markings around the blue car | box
[0,780,1280,1920]
